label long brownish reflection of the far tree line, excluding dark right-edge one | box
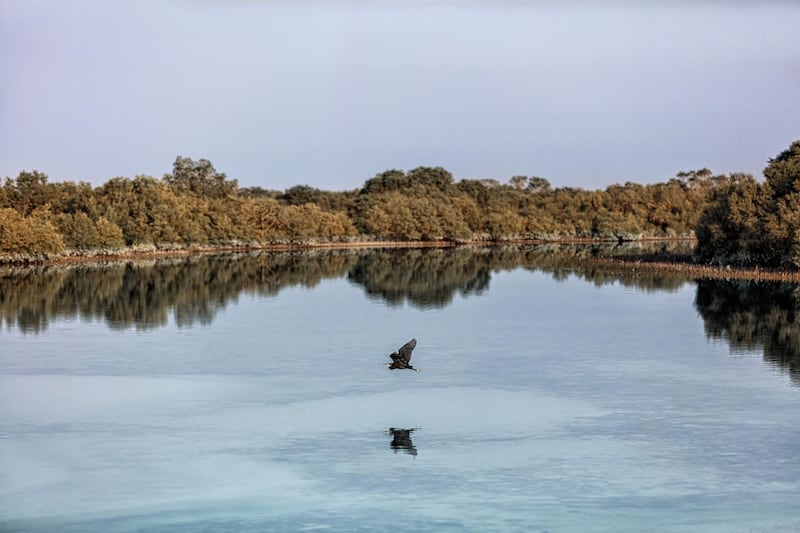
[0,245,744,332]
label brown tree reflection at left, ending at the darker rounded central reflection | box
[0,252,357,333]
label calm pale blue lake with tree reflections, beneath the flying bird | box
[0,247,800,532]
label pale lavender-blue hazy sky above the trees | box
[0,0,800,190]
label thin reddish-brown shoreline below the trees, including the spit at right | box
[0,238,800,283]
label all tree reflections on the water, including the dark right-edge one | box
[0,236,800,394]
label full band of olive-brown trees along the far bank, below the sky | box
[0,141,800,267]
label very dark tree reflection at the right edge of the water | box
[695,280,800,384]
